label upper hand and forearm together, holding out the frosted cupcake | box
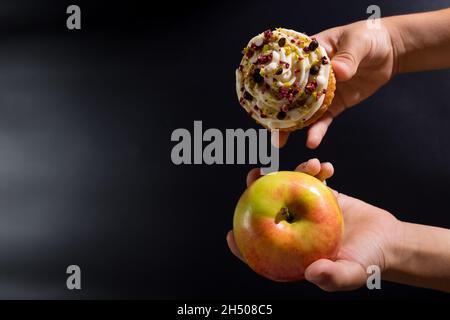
[272,9,450,149]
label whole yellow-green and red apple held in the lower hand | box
[233,171,344,281]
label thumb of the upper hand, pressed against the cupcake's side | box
[331,33,370,81]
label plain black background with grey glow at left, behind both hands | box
[0,0,450,299]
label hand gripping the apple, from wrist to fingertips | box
[227,159,401,291]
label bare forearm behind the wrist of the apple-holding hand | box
[383,222,450,292]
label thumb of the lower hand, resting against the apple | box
[305,259,367,291]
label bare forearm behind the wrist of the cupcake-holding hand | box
[383,9,450,73]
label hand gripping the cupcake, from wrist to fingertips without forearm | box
[272,20,395,149]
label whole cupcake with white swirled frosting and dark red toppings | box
[236,28,336,131]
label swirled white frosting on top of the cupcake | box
[236,29,331,129]
